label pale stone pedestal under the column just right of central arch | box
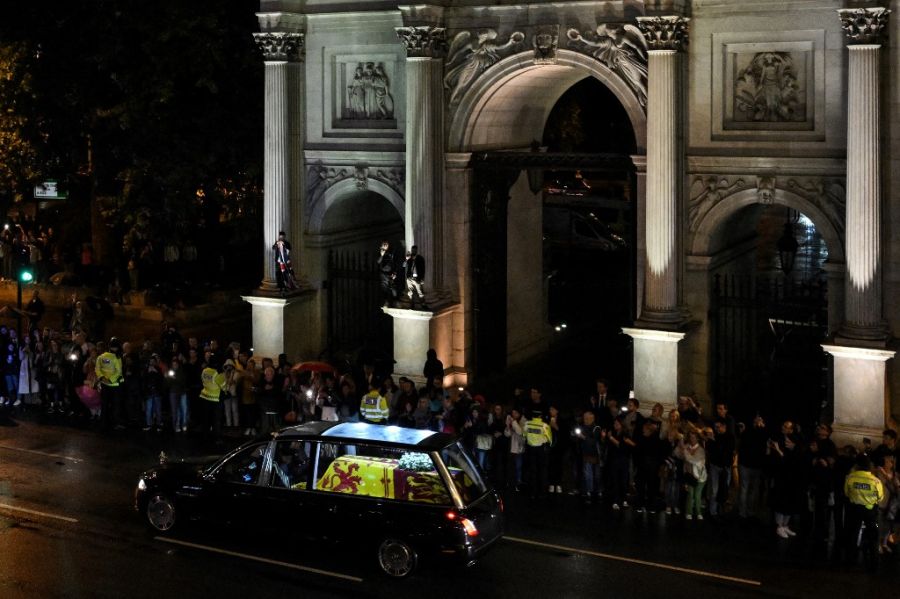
[622,328,685,413]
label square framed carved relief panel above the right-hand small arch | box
[711,30,825,141]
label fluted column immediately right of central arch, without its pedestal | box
[637,16,688,327]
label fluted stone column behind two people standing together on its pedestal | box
[397,25,445,292]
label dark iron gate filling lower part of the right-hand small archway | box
[710,274,828,424]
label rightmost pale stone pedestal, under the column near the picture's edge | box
[822,345,894,447]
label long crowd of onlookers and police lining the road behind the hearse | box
[0,316,900,564]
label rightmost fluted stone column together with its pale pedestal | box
[822,8,894,446]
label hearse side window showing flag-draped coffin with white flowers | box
[314,440,451,505]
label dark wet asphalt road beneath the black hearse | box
[0,412,900,599]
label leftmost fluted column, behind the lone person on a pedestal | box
[253,32,304,293]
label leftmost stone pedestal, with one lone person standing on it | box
[241,289,321,362]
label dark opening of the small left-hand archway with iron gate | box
[309,190,404,364]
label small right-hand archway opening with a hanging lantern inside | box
[710,204,830,427]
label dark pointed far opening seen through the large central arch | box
[543,77,637,335]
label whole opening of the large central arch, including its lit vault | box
[466,68,641,392]
